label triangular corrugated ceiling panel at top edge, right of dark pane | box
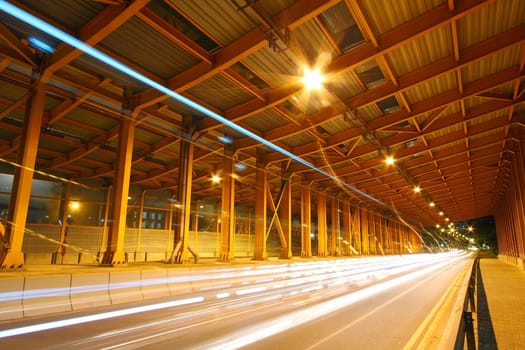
[361,0,446,34]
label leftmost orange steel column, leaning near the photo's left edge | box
[0,71,46,269]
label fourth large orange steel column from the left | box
[219,149,235,261]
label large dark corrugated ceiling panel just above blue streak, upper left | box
[100,18,199,79]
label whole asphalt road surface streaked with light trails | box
[0,254,470,350]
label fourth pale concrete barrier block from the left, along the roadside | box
[109,271,143,304]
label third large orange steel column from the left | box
[170,115,193,264]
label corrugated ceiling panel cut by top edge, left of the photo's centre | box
[169,0,254,46]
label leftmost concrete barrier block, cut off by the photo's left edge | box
[0,277,24,321]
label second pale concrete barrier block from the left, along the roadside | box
[22,275,71,317]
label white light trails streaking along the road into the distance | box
[0,252,467,350]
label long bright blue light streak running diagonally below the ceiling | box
[0,0,388,207]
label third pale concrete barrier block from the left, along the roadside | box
[70,272,111,310]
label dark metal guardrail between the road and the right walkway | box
[454,257,479,350]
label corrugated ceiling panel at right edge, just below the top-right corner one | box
[462,46,520,84]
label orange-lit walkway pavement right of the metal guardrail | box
[474,258,525,350]
